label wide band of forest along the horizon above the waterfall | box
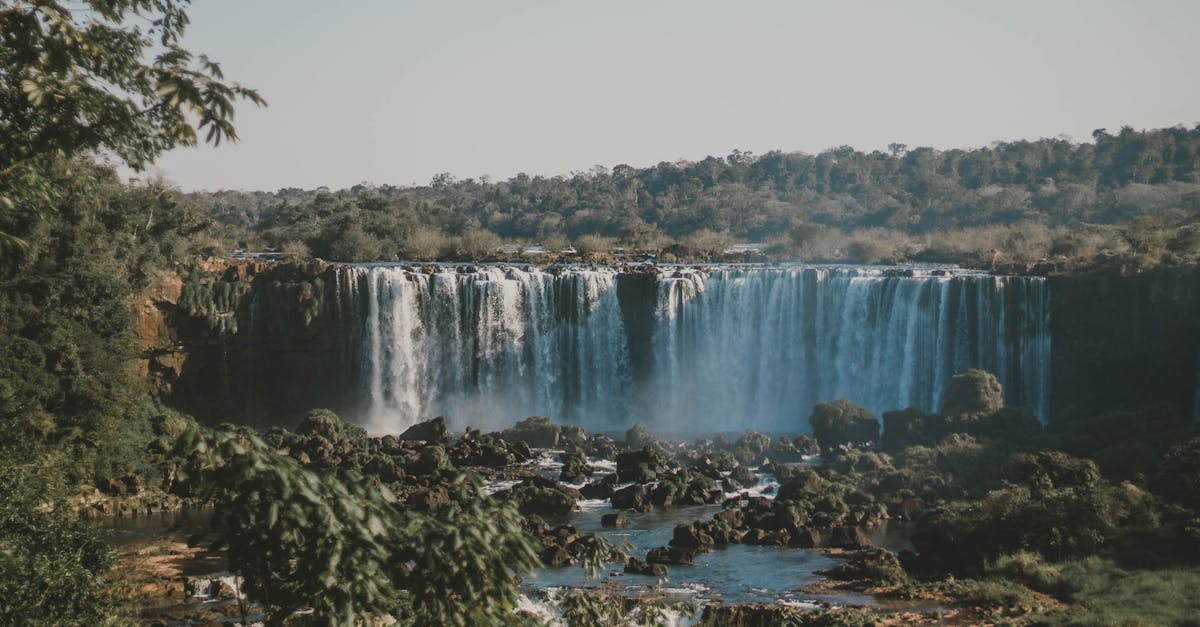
[190,126,1200,263]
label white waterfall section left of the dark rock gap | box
[344,265,630,431]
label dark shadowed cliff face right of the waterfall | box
[1050,268,1200,418]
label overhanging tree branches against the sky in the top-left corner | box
[0,0,265,253]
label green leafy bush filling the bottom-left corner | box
[0,466,115,625]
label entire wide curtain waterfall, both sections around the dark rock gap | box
[337,260,1050,432]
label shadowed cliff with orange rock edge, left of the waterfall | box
[133,261,355,425]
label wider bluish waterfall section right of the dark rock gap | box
[648,267,1050,431]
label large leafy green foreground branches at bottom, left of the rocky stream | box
[180,416,539,625]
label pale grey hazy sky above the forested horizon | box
[145,0,1200,191]
